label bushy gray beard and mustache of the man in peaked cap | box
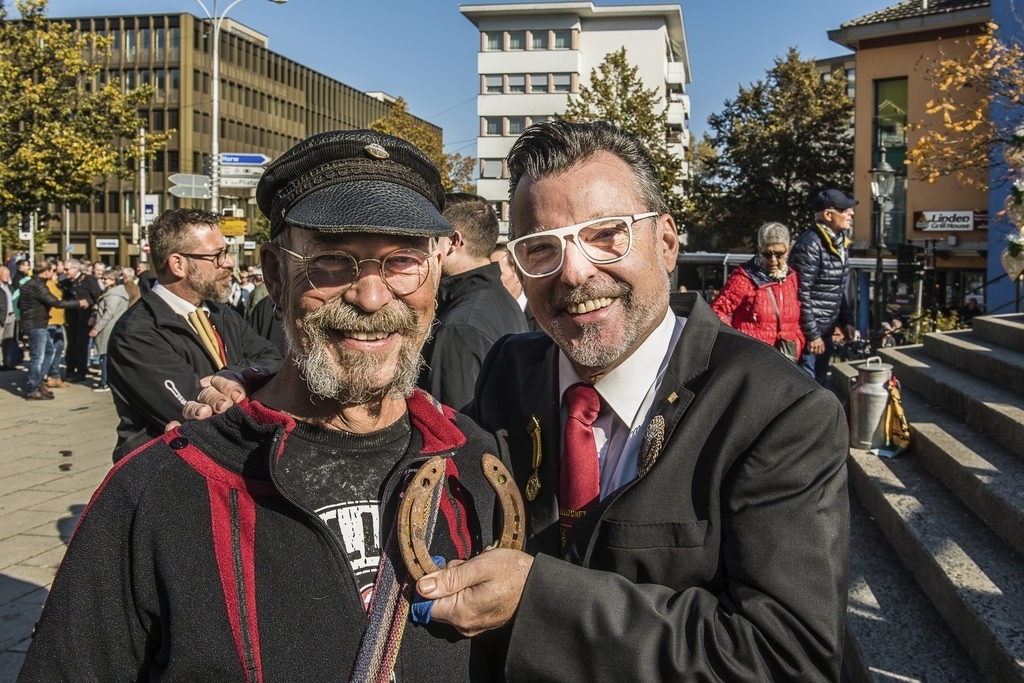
[283,299,423,404]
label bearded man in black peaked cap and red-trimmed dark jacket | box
[18,131,500,683]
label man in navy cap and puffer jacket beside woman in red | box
[790,189,857,386]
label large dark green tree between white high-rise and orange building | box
[683,48,853,251]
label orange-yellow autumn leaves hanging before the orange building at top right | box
[907,23,1024,189]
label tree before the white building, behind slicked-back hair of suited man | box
[560,47,683,218]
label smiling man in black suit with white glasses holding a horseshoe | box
[417,121,849,682]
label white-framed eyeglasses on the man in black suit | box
[508,211,660,278]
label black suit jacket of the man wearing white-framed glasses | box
[467,294,849,683]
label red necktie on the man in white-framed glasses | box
[558,384,601,547]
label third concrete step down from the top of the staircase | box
[880,345,1024,456]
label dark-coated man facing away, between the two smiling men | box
[419,193,528,408]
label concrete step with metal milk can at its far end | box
[849,450,1024,682]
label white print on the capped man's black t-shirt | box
[316,501,381,607]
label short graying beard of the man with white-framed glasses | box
[545,274,670,368]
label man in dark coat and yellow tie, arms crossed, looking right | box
[106,209,282,462]
